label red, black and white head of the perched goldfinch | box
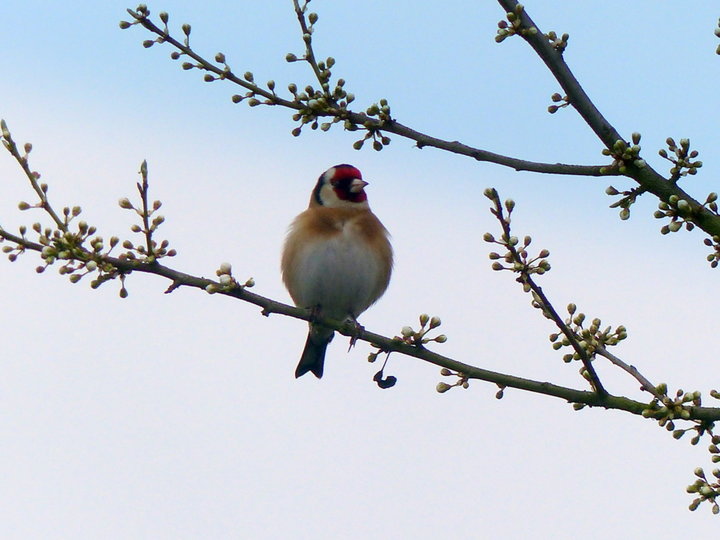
[310,164,368,209]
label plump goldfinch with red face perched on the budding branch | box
[281,163,393,379]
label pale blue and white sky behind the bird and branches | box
[0,0,720,539]
